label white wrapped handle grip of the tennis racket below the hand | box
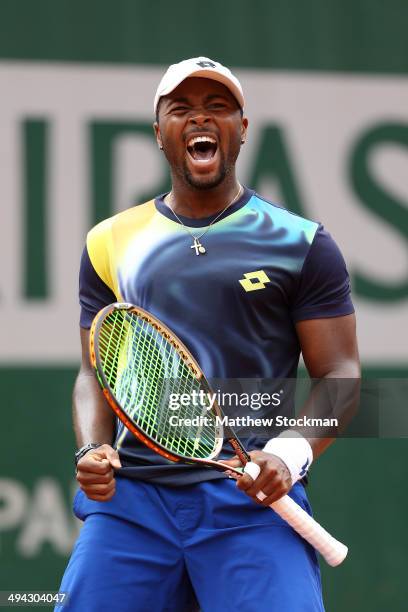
[257,491,348,567]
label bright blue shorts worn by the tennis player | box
[56,478,324,612]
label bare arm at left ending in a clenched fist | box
[73,329,121,501]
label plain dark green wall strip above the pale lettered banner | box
[0,0,408,73]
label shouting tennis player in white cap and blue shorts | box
[61,57,359,612]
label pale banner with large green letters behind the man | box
[0,62,408,365]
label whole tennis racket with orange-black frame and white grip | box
[90,303,347,566]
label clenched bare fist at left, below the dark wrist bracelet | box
[76,444,122,501]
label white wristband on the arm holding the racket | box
[263,429,313,485]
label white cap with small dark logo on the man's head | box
[154,57,244,113]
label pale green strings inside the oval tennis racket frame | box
[99,310,219,458]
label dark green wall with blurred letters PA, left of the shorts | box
[0,368,75,590]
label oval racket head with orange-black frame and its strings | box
[90,302,225,470]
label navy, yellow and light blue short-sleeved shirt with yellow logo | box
[80,189,354,485]
